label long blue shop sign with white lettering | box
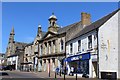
[65,52,90,62]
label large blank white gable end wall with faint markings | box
[98,10,120,78]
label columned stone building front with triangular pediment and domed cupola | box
[39,14,65,72]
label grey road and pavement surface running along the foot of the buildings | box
[0,71,101,80]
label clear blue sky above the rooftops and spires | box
[0,2,118,53]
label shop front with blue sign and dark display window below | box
[65,53,91,75]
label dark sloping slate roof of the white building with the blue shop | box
[67,8,120,42]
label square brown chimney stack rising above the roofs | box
[81,12,91,27]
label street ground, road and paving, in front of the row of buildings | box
[0,71,101,80]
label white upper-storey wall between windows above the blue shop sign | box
[66,31,97,56]
